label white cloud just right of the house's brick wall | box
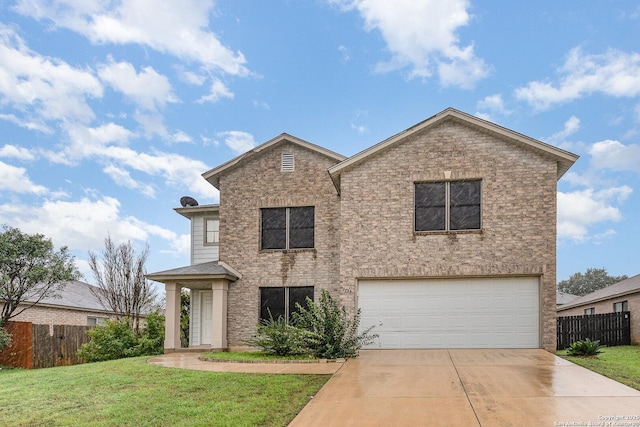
[558,185,633,242]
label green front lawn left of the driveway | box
[0,357,329,426]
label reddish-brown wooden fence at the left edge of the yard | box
[0,322,90,369]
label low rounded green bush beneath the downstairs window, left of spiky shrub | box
[247,312,310,356]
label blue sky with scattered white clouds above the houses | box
[0,0,640,283]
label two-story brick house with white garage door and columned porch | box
[147,108,578,352]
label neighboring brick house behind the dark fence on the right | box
[558,274,640,345]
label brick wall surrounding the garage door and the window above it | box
[340,120,557,351]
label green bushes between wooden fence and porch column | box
[78,313,164,362]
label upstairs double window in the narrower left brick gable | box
[260,206,315,250]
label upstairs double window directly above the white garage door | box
[415,180,481,231]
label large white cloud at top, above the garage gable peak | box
[329,0,489,88]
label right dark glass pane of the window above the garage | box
[449,181,480,230]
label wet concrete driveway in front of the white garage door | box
[290,350,640,426]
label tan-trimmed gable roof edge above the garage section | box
[329,108,579,192]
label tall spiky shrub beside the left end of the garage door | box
[293,289,378,359]
